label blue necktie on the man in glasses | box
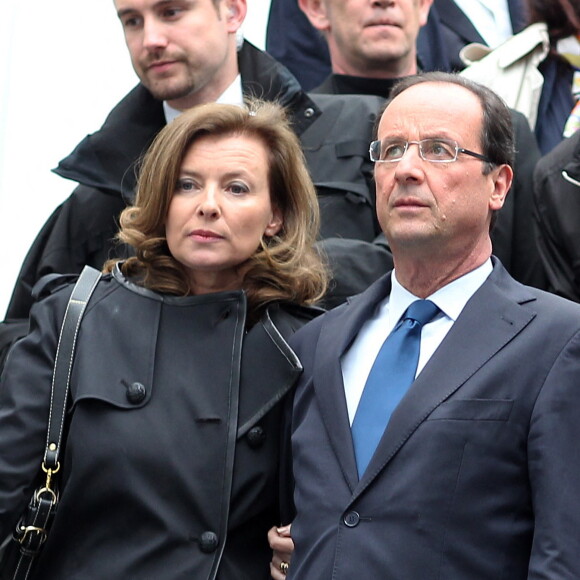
[352,300,439,478]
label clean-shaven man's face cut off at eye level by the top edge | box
[308,0,432,78]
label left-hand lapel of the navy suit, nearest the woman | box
[313,274,391,491]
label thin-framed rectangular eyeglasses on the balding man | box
[369,139,493,163]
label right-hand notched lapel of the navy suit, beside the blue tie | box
[355,262,535,496]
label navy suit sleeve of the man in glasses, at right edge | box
[528,333,580,580]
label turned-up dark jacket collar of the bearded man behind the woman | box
[53,41,321,202]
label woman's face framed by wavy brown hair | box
[165,135,282,294]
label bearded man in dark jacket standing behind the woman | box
[6,0,390,328]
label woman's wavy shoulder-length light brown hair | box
[105,100,328,309]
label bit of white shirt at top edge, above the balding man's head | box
[455,0,514,48]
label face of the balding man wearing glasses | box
[375,83,511,259]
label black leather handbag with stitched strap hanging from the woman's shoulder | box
[0,266,101,580]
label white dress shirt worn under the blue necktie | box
[340,259,493,425]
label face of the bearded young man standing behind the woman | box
[115,0,246,109]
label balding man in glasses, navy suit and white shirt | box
[270,73,580,580]
